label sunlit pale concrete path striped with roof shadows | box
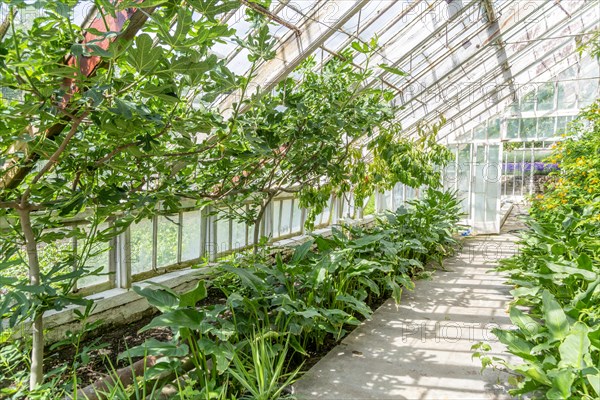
[295,211,520,400]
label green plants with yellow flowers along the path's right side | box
[479,99,600,399]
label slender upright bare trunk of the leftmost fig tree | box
[19,209,44,390]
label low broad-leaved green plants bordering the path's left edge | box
[123,189,460,399]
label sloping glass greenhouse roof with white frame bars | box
[216,0,600,145]
